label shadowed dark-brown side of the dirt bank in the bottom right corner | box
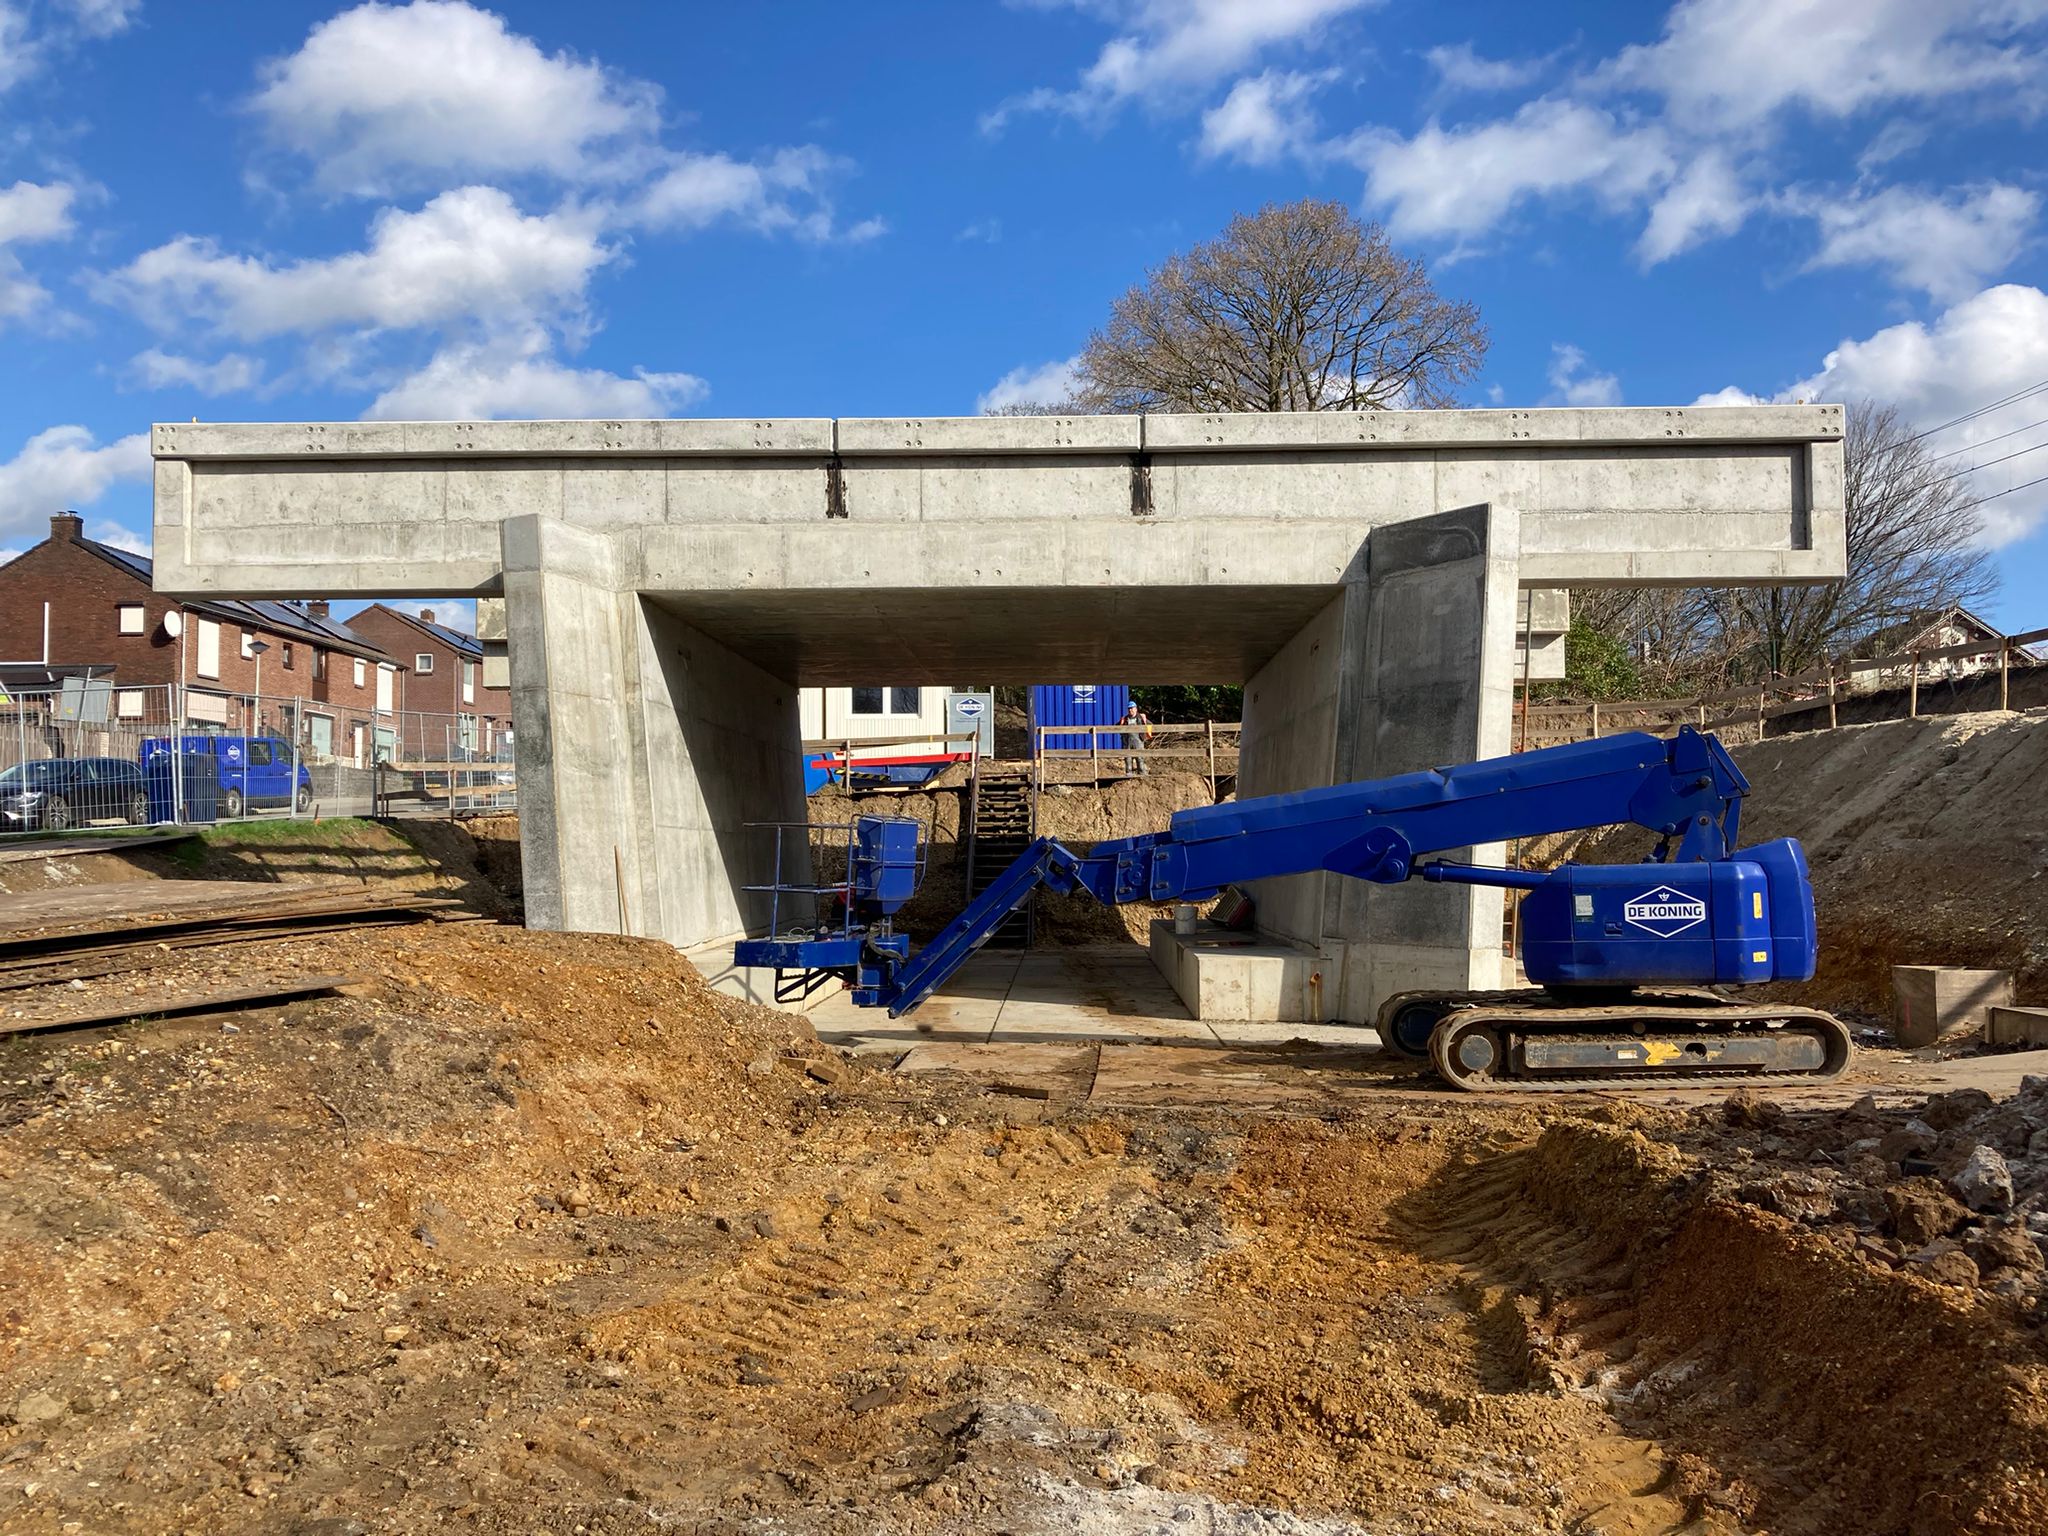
[1415,1116,2048,1536]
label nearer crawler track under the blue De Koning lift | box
[1430,1011,1853,1094]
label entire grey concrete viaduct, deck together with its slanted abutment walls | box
[152,406,1845,1020]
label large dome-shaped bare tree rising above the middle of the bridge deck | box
[1077,199,1487,412]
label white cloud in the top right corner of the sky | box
[1595,0,2042,129]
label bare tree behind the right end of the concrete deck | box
[1573,399,1999,692]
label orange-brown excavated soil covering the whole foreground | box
[0,924,2048,1536]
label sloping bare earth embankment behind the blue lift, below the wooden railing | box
[1552,711,2048,1018]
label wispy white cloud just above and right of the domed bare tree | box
[1350,98,1673,240]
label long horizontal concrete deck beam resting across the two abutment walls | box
[152,406,1843,596]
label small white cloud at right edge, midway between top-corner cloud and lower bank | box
[1786,182,2040,301]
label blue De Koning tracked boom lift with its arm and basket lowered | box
[733,727,1851,1090]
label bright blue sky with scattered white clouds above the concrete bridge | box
[0,0,2048,629]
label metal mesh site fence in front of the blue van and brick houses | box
[0,678,516,838]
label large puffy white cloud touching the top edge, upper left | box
[250,0,659,195]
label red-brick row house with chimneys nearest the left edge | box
[0,512,403,766]
